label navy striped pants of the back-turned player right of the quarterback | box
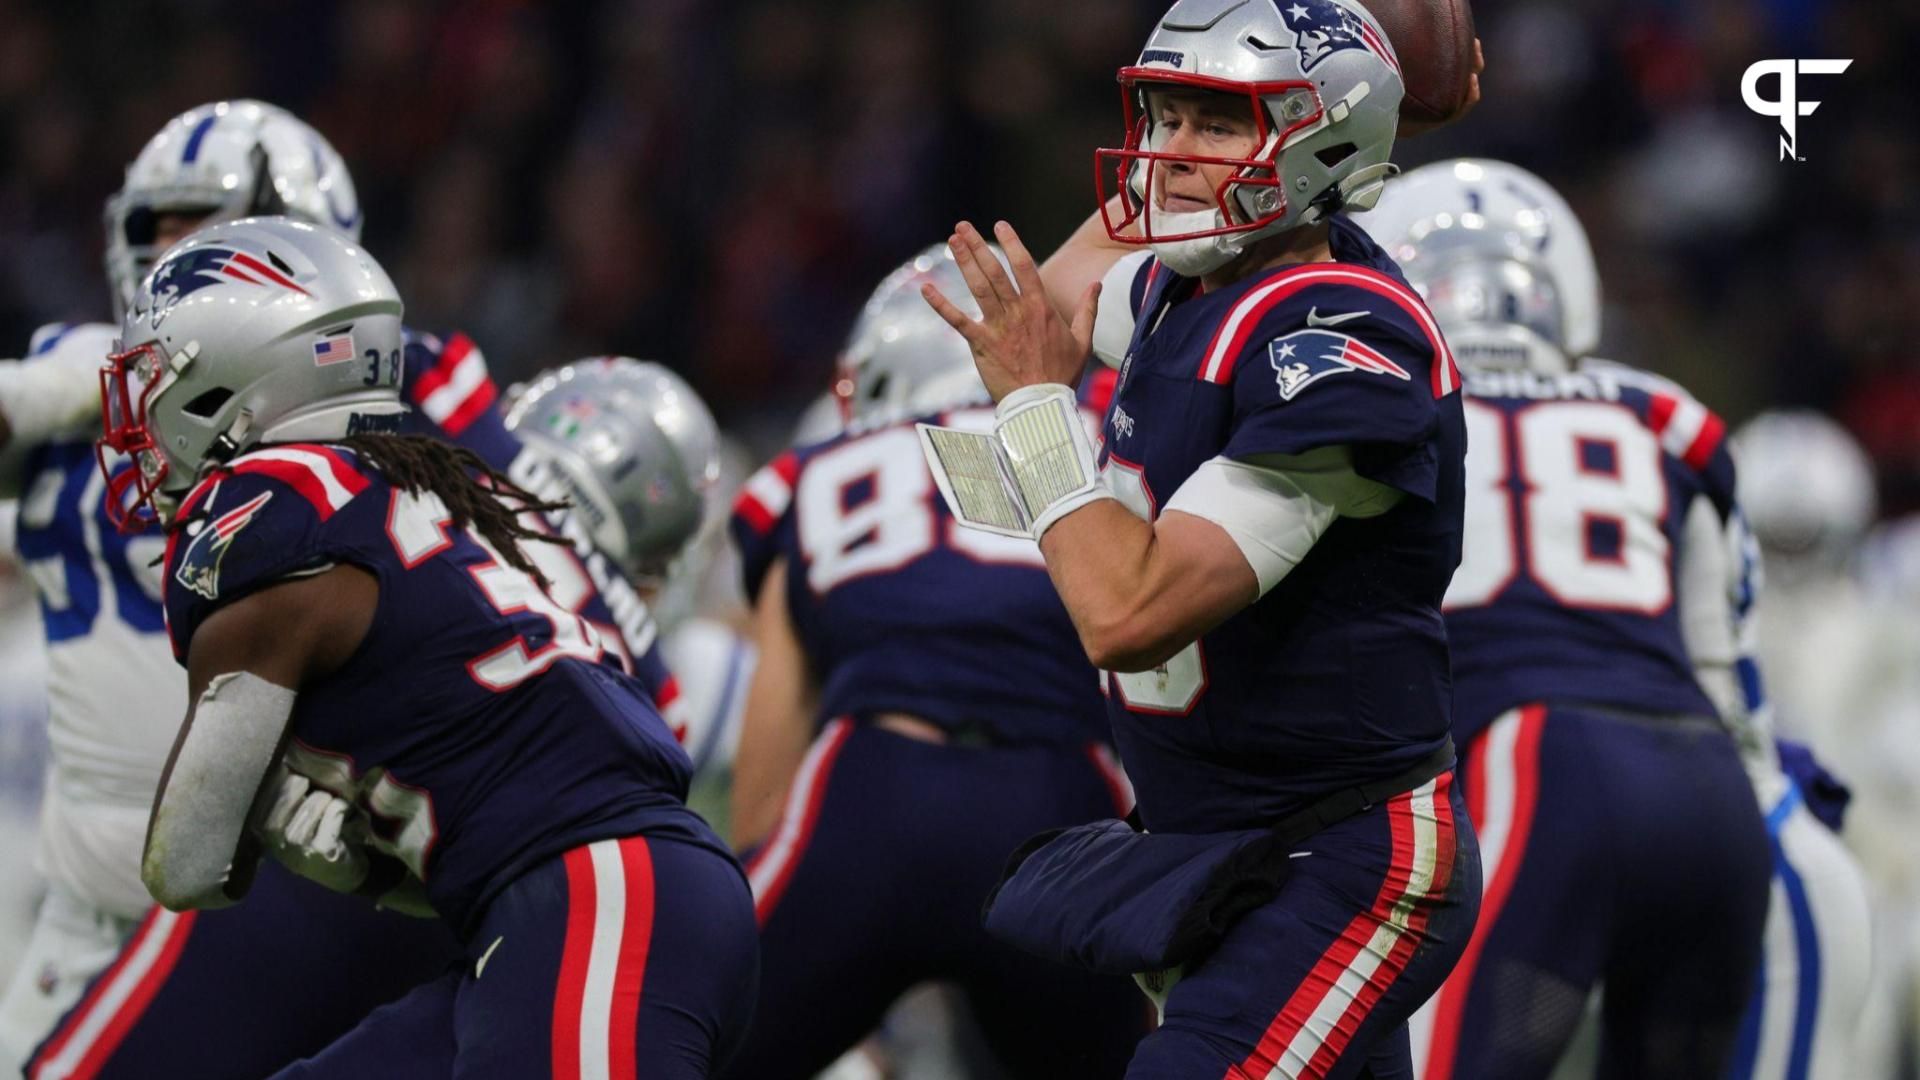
[1415,705,1772,1080]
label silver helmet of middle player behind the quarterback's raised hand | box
[833,244,1012,423]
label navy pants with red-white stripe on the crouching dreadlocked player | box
[276,836,756,1080]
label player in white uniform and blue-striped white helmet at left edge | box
[0,94,361,1065]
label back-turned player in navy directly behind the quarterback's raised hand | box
[728,248,1146,1080]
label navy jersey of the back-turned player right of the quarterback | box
[1446,367,1734,742]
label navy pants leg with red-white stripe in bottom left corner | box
[27,861,459,1080]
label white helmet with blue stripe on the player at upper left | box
[106,100,361,317]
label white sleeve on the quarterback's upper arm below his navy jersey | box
[1167,446,1402,596]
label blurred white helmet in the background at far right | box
[1734,409,1878,569]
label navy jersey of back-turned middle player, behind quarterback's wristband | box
[733,409,1110,748]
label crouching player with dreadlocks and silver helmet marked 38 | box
[90,219,755,1076]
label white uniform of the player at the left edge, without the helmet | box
[0,325,166,1068]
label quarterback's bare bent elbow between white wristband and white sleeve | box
[1041,500,1260,671]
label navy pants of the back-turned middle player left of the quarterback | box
[728,719,1148,1080]
